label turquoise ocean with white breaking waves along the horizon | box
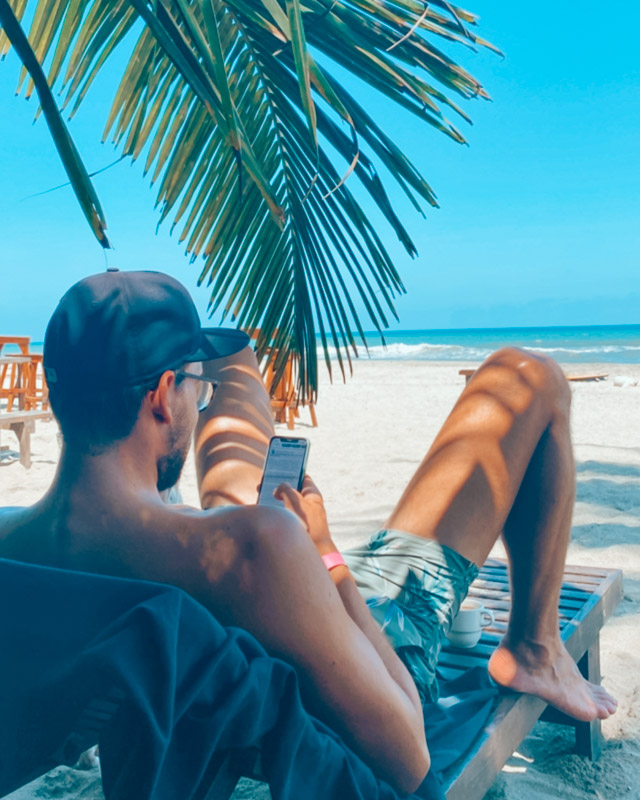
[10,325,640,364]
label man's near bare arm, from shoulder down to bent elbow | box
[164,506,429,793]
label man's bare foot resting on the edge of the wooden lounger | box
[489,643,618,722]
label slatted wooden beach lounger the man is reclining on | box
[198,558,622,800]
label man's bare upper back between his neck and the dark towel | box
[0,496,258,624]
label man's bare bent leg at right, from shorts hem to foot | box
[387,349,616,720]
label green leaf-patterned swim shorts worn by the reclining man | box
[343,529,478,703]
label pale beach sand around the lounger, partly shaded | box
[0,361,640,800]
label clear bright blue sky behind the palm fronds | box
[0,0,640,340]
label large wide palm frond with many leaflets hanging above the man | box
[0,0,495,400]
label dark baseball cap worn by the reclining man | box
[44,269,249,391]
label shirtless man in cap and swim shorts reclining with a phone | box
[0,271,616,792]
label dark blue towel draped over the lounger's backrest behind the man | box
[0,559,442,800]
